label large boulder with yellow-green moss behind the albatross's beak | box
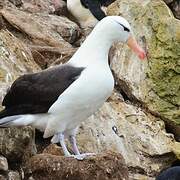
[108,0,180,139]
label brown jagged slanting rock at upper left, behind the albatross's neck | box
[1,7,80,68]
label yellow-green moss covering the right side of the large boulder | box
[147,1,180,124]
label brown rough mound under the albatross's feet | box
[30,152,128,180]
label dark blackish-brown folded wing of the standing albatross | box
[0,65,84,118]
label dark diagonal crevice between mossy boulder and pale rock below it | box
[112,71,180,142]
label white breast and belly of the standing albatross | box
[45,66,114,136]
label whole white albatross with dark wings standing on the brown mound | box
[0,16,145,159]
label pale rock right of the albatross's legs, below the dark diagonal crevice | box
[74,93,176,177]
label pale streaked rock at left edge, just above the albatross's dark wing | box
[0,30,40,105]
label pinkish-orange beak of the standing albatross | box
[127,36,146,60]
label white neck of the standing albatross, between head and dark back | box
[69,29,113,67]
